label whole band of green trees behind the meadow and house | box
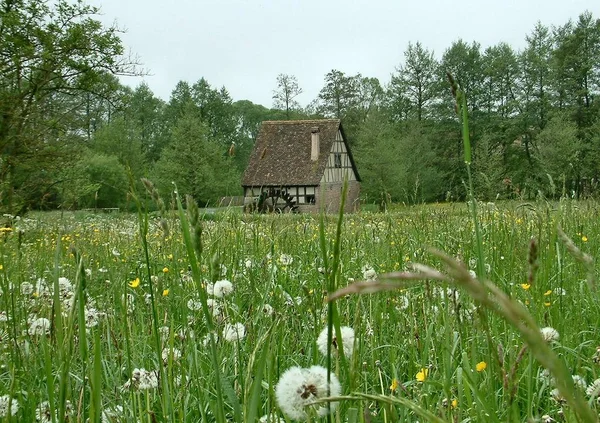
[0,0,600,214]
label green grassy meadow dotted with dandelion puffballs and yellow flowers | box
[0,199,600,423]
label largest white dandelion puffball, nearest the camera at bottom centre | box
[275,366,342,420]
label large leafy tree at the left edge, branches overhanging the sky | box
[0,0,137,214]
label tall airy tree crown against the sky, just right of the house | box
[389,42,439,121]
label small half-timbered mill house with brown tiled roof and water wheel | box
[242,119,360,213]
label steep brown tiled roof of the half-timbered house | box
[242,119,350,186]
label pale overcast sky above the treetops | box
[89,0,600,107]
